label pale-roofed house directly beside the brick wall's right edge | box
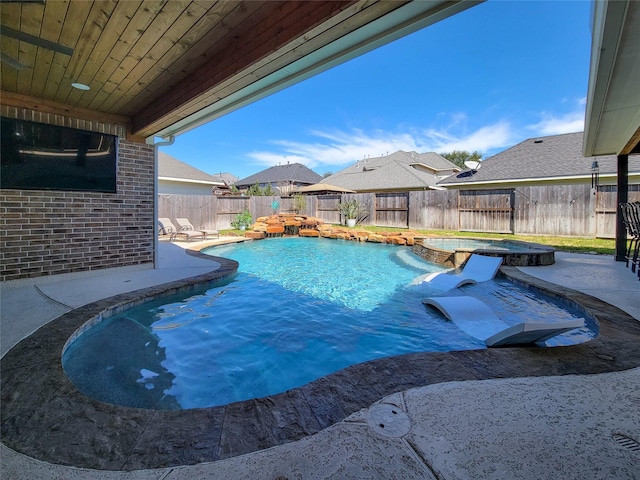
[158,151,229,195]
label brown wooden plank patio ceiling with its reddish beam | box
[0,0,466,137]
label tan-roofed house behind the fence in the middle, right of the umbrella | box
[323,150,461,193]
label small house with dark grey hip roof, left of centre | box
[235,163,322,194]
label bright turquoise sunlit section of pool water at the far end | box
[204,238,443,312]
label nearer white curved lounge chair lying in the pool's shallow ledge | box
[422,296,584,347]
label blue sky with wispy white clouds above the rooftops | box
[161,0,591,178]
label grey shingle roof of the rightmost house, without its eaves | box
[438,132,640,185]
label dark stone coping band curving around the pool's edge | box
[0,251,640,471]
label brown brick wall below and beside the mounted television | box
[0,138,154,281]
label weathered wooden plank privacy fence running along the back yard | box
[158,185,640,238]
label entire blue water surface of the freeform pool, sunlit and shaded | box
[63,238,595,409]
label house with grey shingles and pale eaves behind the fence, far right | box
[438,132,640,189]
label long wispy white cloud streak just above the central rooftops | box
[249,120,514,170]
